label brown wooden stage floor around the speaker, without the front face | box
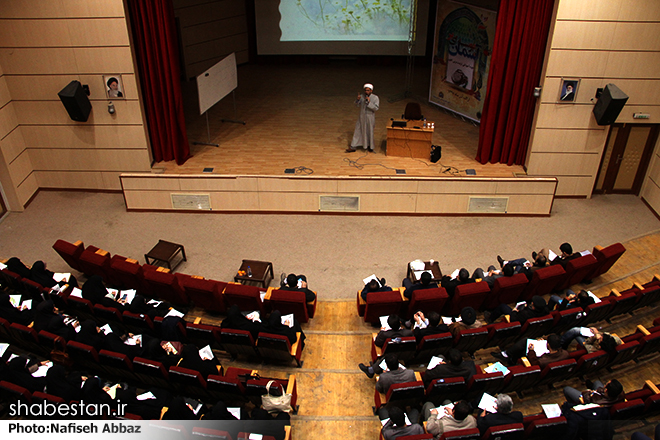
[161,61,525,177]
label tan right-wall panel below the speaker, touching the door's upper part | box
[534,128,608,153]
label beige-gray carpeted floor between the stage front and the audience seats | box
[0,191,660,300]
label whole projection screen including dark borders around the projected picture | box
[255,0,429,55]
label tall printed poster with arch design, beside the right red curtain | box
[429,0,497,122]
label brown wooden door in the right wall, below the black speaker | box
[594,124,660,195]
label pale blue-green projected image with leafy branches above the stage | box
[279,0,412,41]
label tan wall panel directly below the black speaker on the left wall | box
[18,121,147,150]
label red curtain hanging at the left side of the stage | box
[128,0,190,165]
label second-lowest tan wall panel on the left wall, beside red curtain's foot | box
[28,149,150,174]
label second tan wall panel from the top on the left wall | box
[0,17,129,47]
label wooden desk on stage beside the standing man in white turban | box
[387,121,433,160]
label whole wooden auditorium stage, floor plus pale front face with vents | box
[121,61,557,215]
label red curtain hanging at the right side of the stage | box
[476,0,554,165]
